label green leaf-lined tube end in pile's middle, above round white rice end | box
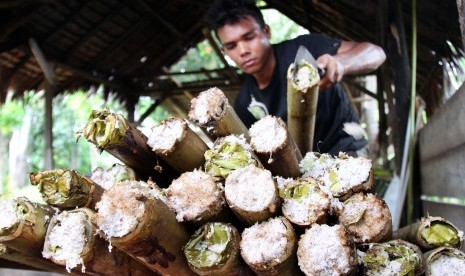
[205,135,263,179]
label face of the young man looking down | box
[217,16,272,74]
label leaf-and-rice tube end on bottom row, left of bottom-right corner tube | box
[359,240,425,275]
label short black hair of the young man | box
[205,0,265,32]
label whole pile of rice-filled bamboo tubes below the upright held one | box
[0,85,465,275]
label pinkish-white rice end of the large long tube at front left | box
[95,181,146,238]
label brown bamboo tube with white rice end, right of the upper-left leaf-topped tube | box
[147,118,208,173]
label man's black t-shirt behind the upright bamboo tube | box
[234,34,366,155]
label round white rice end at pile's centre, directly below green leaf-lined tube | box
[225,165,277,212]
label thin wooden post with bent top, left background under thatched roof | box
[29,38,56,170]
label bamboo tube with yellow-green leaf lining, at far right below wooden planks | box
[393,216,463,250]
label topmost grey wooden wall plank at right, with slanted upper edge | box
[420,82,465,162]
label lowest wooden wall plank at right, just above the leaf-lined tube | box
[423,201,465,231]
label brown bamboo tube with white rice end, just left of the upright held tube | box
[249,116,302,177]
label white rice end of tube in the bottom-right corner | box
[430,254,465,276]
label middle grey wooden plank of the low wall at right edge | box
[421,144,465,198]
